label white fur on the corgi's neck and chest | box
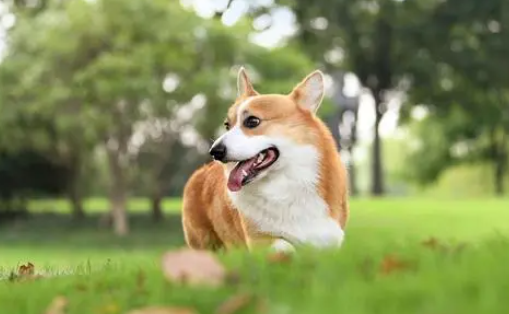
[229,141,344,247]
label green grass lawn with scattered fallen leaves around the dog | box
[0,199,509,314]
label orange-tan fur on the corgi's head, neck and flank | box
[182,70,348,249]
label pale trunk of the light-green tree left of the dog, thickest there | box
[108,149,129,236]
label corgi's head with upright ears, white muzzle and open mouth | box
[210,68,324,192]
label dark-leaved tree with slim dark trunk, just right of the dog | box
[258,0,419,195]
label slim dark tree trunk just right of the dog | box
[371,100,385,196]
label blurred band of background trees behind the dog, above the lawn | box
[0,0,509,235]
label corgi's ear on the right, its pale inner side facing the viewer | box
[290,70,324,113]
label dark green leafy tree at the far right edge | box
[405,0,509,195]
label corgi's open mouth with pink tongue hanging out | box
[228,147,279,192]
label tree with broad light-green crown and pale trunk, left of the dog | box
[2,0,211,235]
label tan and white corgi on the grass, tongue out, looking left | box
[182,68,349,251]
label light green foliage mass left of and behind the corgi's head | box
[0,0,312,209]
